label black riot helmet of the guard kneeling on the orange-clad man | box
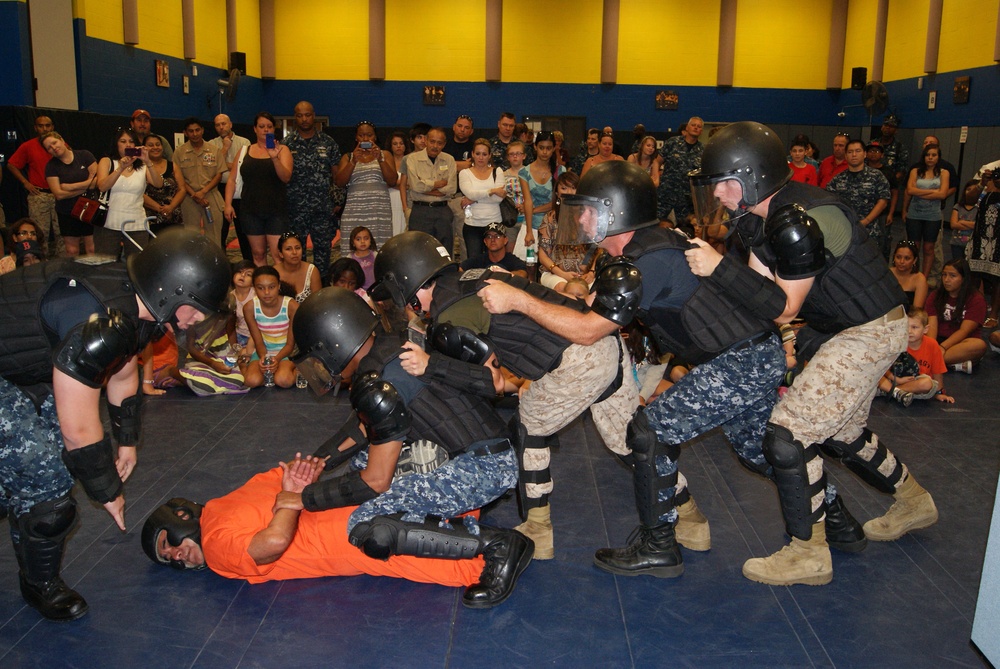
[291,286,379,395]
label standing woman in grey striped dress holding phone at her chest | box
[335,121,396,255]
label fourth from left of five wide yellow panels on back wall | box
[616,0,720,86]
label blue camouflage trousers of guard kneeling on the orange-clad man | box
[347,439,517,533]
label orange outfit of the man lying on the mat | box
[201,467,484,586]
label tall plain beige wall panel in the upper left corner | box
[28,0,80,109]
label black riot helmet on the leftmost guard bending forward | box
[128,227,232,325]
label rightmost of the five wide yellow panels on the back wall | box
[732,0,833,89]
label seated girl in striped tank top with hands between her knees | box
[238,266,299,388]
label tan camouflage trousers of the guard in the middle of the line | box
[518,337,639,499]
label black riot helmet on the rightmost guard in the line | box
[688,121,792,225]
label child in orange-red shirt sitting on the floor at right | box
[878,307,955,406]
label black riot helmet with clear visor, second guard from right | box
[557,160,659,244]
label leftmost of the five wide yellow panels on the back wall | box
[274,0,368,80]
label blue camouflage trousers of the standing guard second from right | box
[646,336,786,522]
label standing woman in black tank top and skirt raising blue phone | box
[226,112,292,267]
